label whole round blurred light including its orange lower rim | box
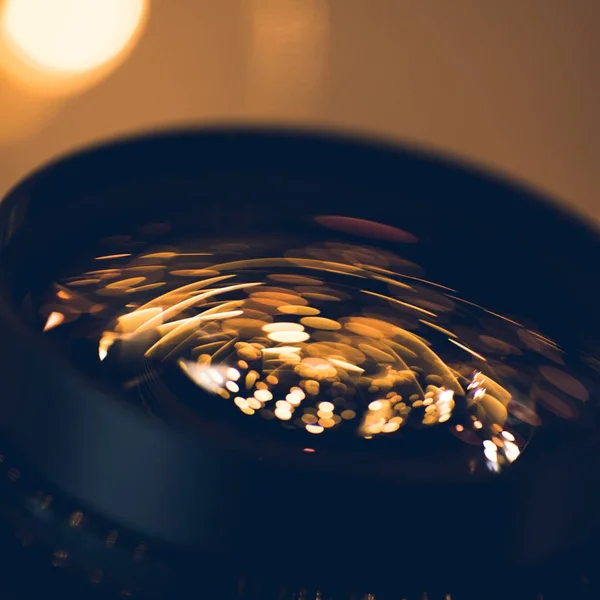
[0,0,149,96]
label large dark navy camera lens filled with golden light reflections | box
[1,131,600,599]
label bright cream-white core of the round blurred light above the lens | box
[2,0,147,74]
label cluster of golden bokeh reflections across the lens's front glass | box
[40,218,589,472]
